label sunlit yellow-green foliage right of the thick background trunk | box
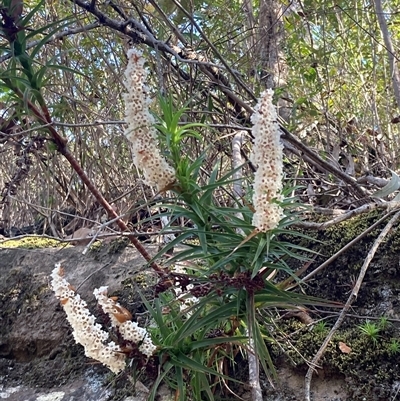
[285,0,399,169]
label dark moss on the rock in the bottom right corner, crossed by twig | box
[272,320,398,401]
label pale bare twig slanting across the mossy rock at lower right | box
[304,211,400,401]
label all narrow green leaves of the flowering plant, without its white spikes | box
[138,98,332,400]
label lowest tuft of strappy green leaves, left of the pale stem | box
[143,293,247,400]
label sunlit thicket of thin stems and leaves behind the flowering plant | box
[0,0,399,234]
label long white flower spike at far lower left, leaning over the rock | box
[51,264,125,373]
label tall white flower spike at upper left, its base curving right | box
[124,49,175,191]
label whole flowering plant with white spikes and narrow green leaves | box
[48,50,319,401]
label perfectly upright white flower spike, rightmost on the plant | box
[251,89,283,232]
